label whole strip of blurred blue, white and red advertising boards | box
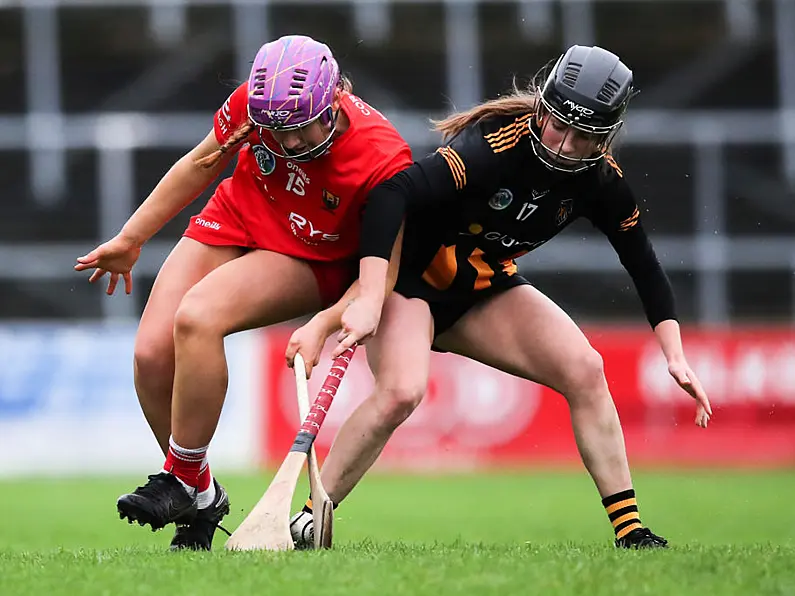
[0,324,795,475]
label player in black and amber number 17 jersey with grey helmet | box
[287,46,712,548]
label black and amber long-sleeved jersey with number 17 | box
[362,114,675,325]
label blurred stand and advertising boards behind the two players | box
[0,0,795,486]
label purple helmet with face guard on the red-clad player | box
[248,35,340,161]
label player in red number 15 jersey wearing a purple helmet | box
[75,36,411,549]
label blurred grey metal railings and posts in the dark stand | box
[0,0,795,323]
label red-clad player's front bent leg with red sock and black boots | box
[116,251,320,536]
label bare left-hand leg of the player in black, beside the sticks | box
[322,293,432,503]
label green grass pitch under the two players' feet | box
[0,471,795,596]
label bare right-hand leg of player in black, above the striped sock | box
[437,286,632,497]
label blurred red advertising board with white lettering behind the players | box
[262,327,795,469]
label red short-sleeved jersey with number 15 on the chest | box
[197,83,412,261]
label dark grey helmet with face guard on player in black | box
[530,46,635,173]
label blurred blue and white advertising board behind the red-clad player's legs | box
[0,323,260,476]
